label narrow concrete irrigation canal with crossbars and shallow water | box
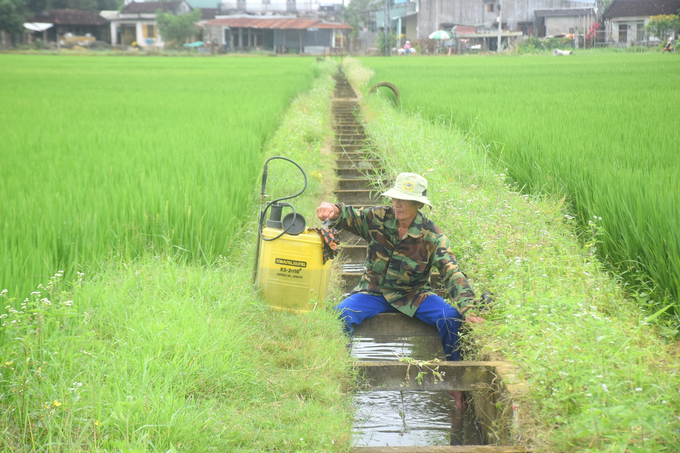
[332,72,527,453]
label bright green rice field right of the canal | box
[361,54,680,313]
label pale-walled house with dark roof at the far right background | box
[603,0,680,47]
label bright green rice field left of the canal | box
[0,55,314,300]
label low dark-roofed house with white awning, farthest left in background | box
[24,9,110,42]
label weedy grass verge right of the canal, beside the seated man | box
[345,60,680,452]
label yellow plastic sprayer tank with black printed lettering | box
[258,228,331,312]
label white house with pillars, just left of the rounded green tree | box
[111,1,193,48]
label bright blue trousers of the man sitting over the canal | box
[335,293,462,361]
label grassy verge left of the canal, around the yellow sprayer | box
[0,59,352,452]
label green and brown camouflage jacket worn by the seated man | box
[334,204,475,316]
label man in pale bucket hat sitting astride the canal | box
[316,173,484,408]
